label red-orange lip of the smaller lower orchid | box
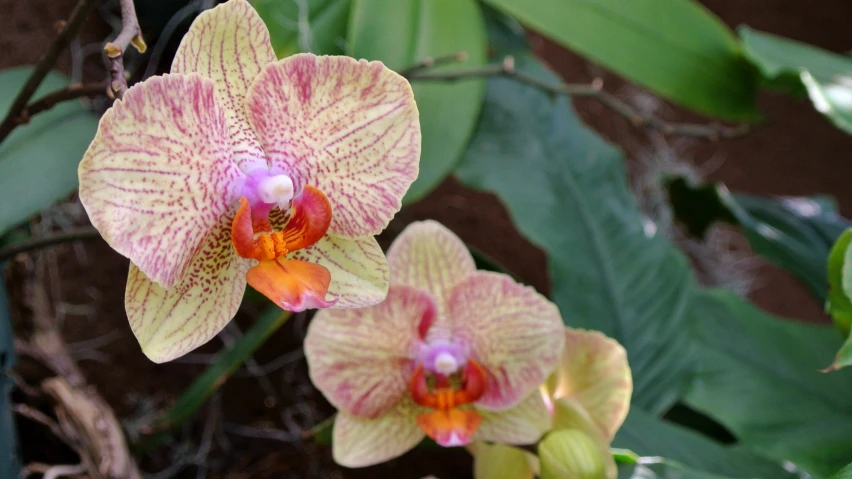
[409,359,486,447]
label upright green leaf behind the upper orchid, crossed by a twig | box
[349,0,486,202]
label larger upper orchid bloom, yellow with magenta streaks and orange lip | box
[79,0,420,362]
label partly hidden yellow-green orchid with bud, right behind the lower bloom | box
[469,328,633,479]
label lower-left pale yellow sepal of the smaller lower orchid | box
[331,399,426,467]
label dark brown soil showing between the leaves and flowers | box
[6,0,852,479]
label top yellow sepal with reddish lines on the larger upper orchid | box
[172,0,276,172]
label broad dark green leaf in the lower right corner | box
[686,291,852,476]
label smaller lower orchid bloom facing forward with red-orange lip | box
[305,221,565,467]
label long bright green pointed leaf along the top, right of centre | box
[486,0,758,120]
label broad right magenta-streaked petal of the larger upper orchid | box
[246,54,420,238]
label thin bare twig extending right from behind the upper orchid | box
[404,56,751,141]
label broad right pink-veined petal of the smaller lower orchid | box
[447,271,565,410]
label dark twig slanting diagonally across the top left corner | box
[0,0,97,142]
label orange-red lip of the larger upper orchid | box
[231,185,336,311]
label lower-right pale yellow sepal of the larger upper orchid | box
[287,235,390,309]
